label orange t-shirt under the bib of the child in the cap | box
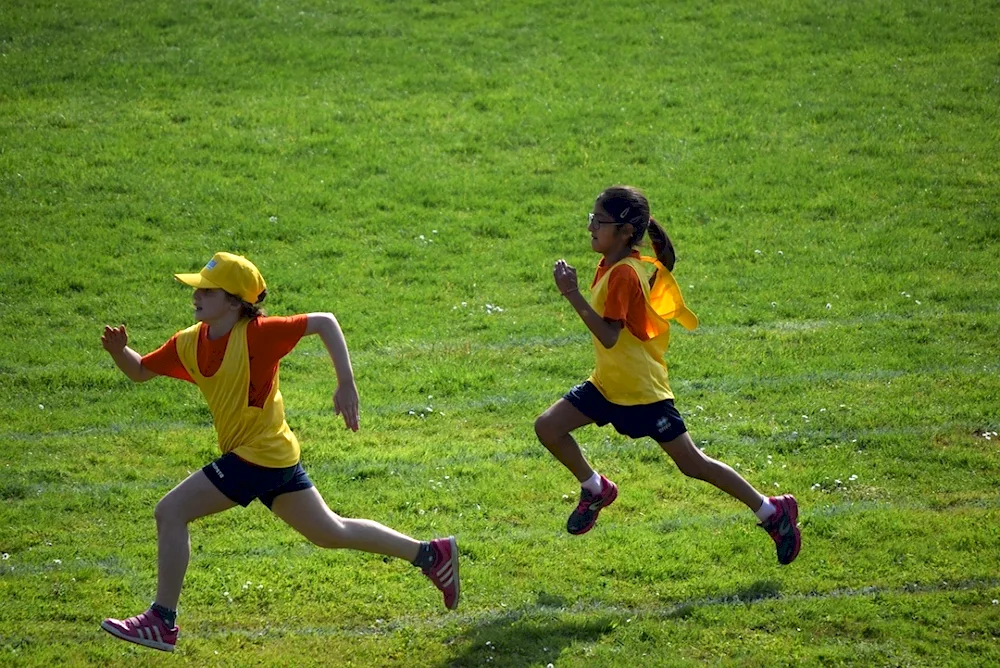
[142,314,309,408]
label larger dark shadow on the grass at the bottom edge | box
[442,592,620,666]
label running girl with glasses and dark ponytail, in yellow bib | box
[535,186,801,564]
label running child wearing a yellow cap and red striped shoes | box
[101,253,459,651]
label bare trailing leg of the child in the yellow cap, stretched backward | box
[271,487,420,562]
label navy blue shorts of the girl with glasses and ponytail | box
[563,380,687,443]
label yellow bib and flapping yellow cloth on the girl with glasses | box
[589,257,698,406]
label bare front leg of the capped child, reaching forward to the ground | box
[155,471,236,610]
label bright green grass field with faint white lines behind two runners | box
[0,0,1000,666]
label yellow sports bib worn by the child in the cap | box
[177,320,299,468]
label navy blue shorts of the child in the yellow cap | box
[201,452,313,508]
